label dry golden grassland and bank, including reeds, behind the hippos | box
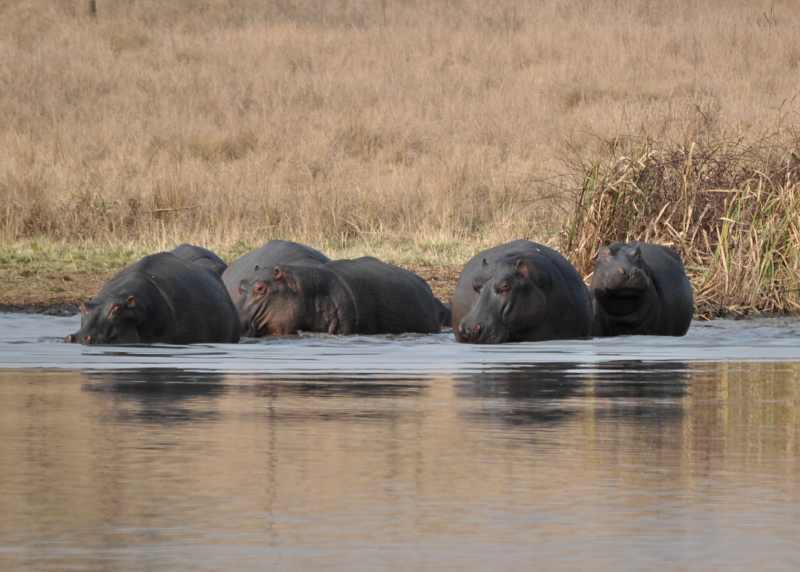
[0,0,800,315]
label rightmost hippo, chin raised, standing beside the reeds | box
[590,242,694,336]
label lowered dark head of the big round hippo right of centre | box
[456,257,553,344]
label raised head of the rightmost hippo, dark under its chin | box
[591,244,654,316]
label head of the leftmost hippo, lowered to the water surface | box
[66,296,142,344]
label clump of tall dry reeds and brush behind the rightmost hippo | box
[562,138,800,317]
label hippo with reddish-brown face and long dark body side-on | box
[234,257,446,337]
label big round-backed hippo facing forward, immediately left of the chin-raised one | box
[452,240,592,344]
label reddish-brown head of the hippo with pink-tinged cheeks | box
[239,265,305,337]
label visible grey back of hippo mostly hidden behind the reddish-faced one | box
[222,240,330,308]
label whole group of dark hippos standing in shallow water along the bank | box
[67,240,694,344]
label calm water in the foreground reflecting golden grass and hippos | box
[0,314,800,571]
